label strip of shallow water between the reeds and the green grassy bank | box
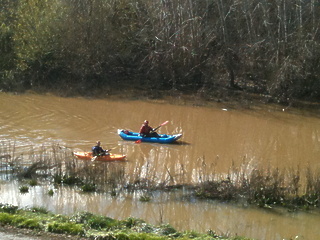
[0,181,320,240]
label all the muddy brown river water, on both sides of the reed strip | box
[0,93,320,239]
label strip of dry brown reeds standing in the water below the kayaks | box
[0,142,320,209]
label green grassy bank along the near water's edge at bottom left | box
[0,204,248,240]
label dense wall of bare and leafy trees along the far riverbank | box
[0,0,320,102]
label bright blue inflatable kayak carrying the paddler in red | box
[118,129,182,143]
